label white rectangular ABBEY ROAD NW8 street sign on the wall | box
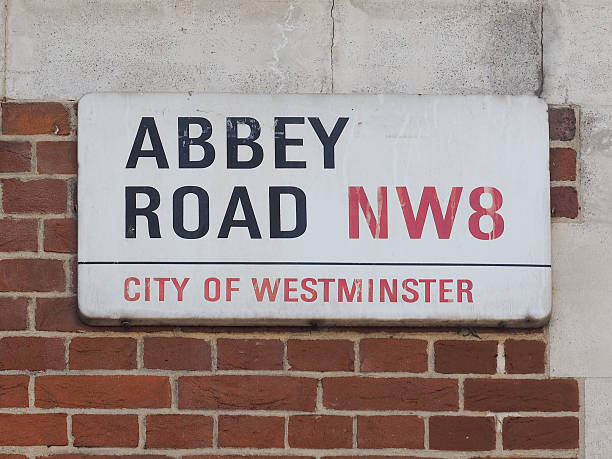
[78,93,551,326]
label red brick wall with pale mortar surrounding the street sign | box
[0,102,584,459]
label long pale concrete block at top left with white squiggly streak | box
[2,0,332,99]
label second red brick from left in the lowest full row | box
[72,414,138,448]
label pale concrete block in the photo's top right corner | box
[543,0,612,104]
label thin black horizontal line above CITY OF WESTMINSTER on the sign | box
[78,261,551,268]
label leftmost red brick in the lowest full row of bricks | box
[0,414,68,446]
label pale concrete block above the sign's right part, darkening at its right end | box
[333,0,541,94]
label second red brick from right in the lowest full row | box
[429,416,495,451]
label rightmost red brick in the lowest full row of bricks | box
[502,417,580,449]
